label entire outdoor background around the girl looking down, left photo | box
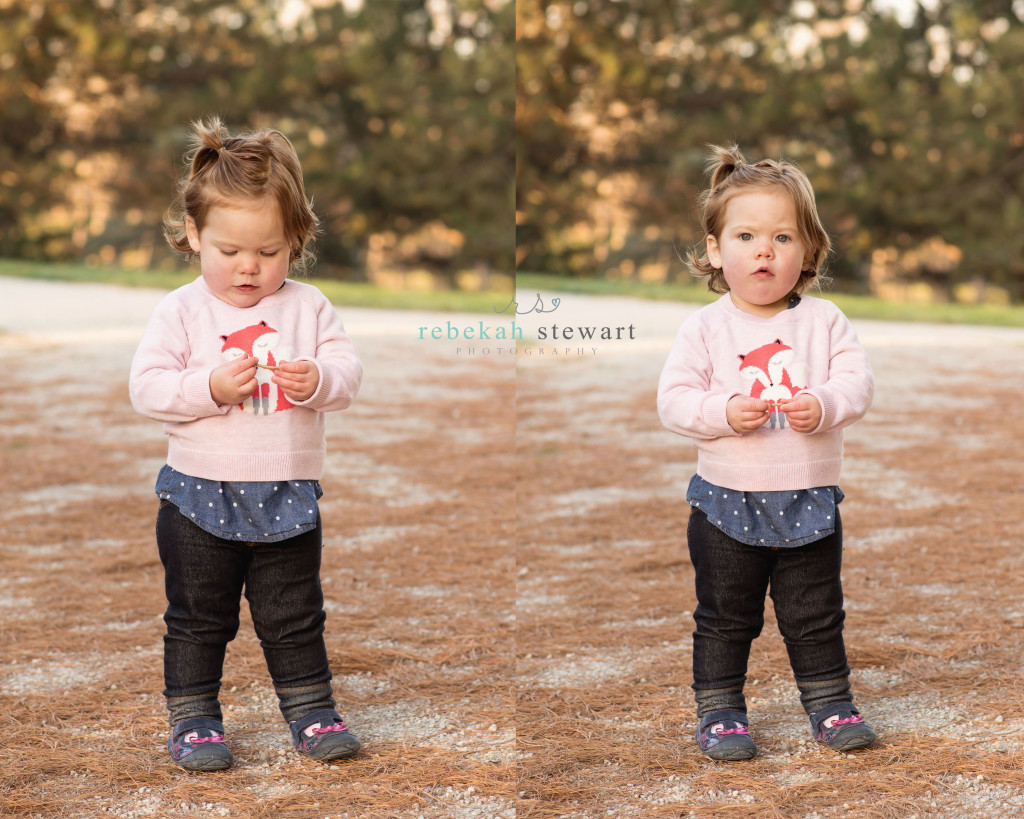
[0,0,516,819]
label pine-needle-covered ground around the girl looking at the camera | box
[516,296,1024,819]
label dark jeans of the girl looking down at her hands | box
[157,502,333,722]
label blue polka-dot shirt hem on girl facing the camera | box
[686,475,844,548]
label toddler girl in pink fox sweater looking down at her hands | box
[130,119,362,771]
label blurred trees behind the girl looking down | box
[0,0,515,283]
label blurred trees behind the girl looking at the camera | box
[516,0,1024,300]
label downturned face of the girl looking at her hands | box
[185,200,291,307]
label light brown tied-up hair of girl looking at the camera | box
[686,145,831,294]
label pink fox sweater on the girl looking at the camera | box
[657,294,874,491]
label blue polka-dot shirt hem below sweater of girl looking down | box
[156,464,324,543]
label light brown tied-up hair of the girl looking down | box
[164,117,318,270]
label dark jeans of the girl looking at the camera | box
[687,509,850,713]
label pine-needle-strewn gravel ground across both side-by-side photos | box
[6,283,1024,819]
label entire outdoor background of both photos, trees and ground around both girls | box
[6,6,1024,819]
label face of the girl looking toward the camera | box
[708,188,807,316]
